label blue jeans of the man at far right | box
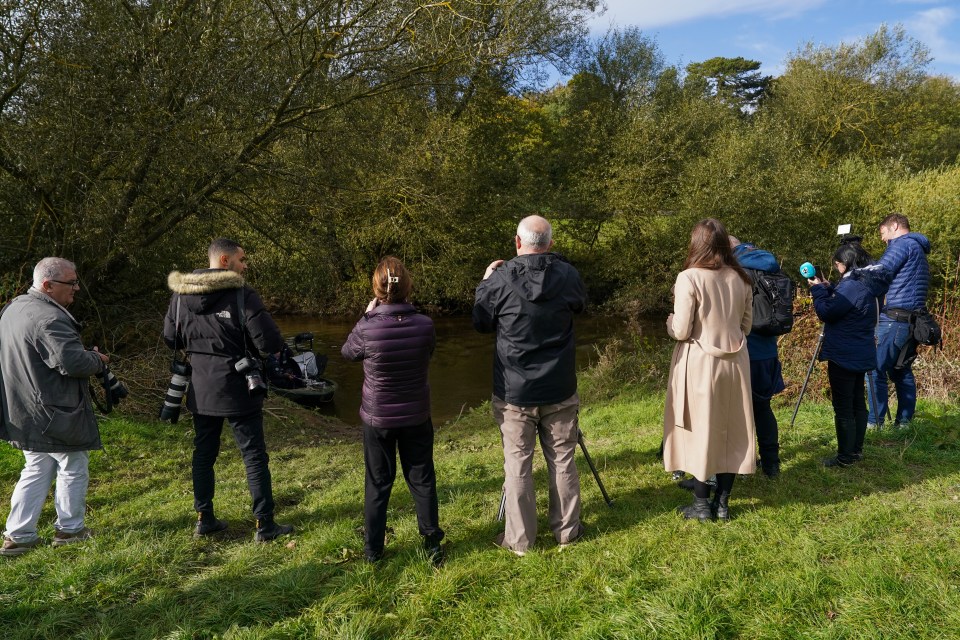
[867,316,917,424]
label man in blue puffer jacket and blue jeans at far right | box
[868,213,930,428]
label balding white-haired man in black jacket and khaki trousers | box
[473,216,586,556]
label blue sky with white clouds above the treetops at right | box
[591,0,960,82]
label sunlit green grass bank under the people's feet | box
[0,388,960,640]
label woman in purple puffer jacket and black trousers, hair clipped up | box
[340,256,443,565]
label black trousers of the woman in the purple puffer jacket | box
[363,420,443,556]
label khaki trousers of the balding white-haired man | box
[492,394,583,551]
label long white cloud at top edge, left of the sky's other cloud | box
[601,0,826,29]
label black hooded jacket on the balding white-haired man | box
[473,253,587,406]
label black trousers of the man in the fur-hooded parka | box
[193,411,273,518]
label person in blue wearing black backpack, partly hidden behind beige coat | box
[730,236,784,478]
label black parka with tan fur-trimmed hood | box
[163,269,283,416]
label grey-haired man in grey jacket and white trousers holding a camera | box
[0,258,109,556]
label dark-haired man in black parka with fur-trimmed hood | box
[163,238,293,542]
